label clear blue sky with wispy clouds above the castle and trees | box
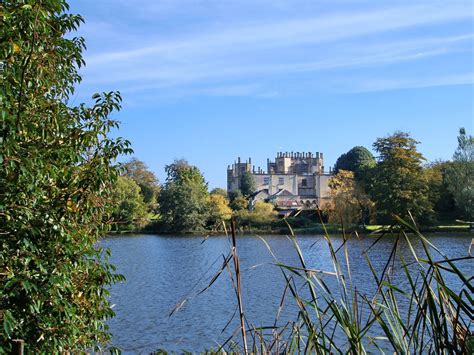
[71,0,474,187]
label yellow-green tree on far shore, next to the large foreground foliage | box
[112,176,149,230]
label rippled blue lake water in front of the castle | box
[101,234,473,353]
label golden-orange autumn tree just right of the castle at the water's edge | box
[328,170,373,226]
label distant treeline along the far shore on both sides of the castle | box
[113,128,474,233]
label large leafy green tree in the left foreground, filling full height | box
[0,0,131,354]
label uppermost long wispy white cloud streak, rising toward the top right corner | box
[88,5,474,65]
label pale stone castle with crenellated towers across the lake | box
[227,152,331,209]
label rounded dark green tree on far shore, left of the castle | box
[159,160,209,233]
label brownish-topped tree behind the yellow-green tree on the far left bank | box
[122,158,160,210]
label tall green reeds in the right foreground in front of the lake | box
[169,216,474,354]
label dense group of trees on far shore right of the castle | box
[328,128,474,224]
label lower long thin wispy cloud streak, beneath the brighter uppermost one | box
[83,34,474,87]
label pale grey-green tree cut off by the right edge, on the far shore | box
[446,128,474,221]
